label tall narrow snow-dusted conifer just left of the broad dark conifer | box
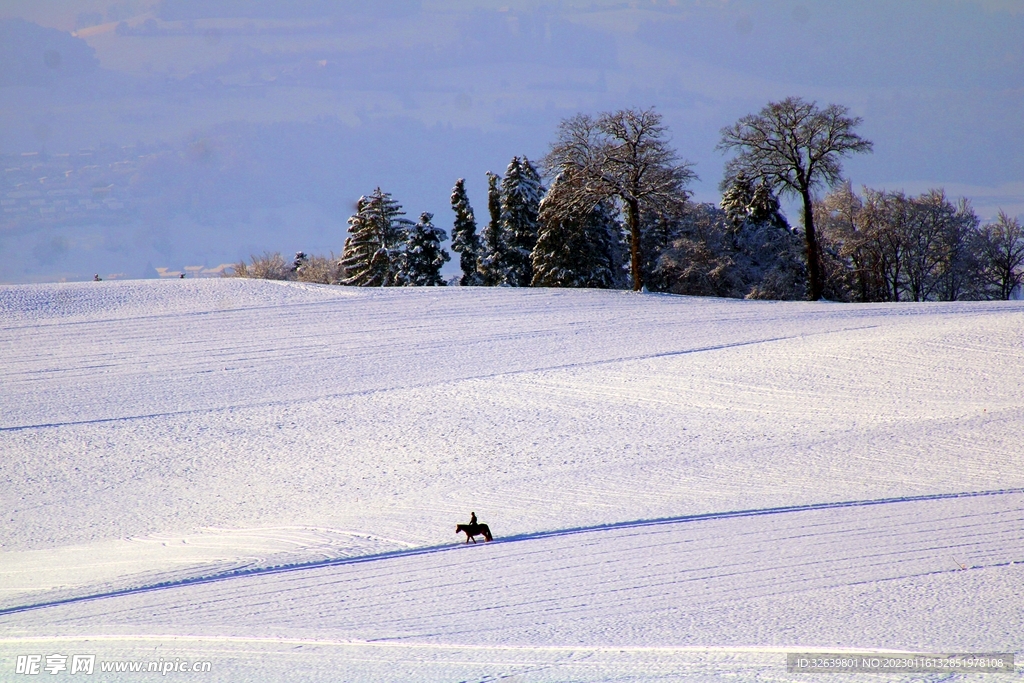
[500,157,544,287]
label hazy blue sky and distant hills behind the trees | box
[0,0,1024,282]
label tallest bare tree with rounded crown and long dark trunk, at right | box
[718,97,872,300]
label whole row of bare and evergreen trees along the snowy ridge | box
[234,97,1024,301]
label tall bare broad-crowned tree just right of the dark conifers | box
[544,109,696,291]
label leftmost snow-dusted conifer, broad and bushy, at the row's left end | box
[340,187,413,287]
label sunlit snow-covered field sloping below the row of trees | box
[0,280,1024,682]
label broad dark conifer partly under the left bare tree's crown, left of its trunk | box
[530,175,626,289]
